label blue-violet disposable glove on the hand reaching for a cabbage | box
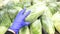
[9,9,30,34]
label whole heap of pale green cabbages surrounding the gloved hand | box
[0,0,60,34]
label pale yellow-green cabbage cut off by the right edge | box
[52,12,60,33]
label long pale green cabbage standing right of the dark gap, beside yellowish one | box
[42,11,55,34]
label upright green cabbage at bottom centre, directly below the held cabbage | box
[30,19,42,34]
